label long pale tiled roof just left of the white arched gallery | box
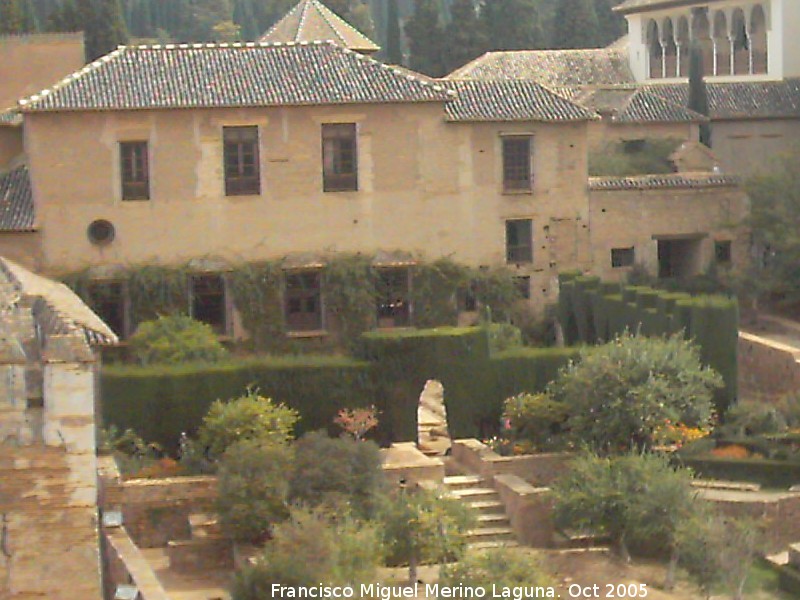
[448,48,635,87]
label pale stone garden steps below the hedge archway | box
[443,475,518,549]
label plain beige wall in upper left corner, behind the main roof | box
[0,33,85,110]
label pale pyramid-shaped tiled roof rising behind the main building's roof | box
[258,0,380,52]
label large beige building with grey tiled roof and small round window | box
[0,0,747,336]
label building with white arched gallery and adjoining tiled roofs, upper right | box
[449,0,800,176]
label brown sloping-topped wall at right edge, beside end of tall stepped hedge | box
[739,331,800,396]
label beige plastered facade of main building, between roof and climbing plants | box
[25,103,590,310]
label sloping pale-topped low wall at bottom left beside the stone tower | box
[102,527,169,600]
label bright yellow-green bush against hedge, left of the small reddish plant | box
[199,389,298,457]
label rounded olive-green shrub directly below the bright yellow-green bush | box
[216,440,291,543]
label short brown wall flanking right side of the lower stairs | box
[494,475,554,548]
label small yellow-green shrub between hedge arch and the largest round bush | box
[503,394,569,450]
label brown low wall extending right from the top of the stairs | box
[452,438,572,487]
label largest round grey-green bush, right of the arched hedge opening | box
[548,334,721,453]
